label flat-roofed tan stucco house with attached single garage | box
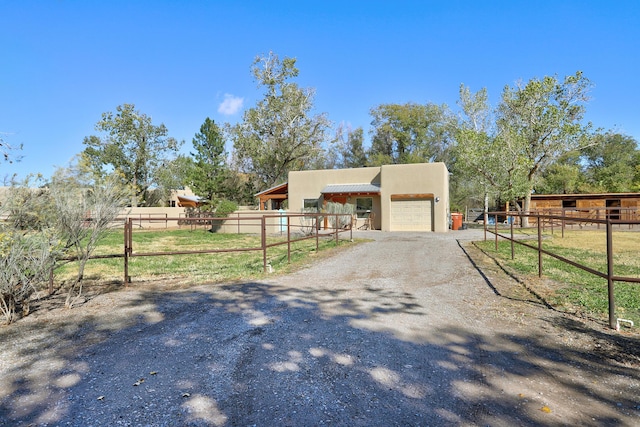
[287,163,449,232]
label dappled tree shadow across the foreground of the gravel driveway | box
[0,276,640,426]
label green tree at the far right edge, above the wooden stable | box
[583,132,640,193]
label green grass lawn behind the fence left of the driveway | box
[55,229,352,290]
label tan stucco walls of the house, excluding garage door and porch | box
[289,163,449,232]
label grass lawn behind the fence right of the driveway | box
[476,228,640,329]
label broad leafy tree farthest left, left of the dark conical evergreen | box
[83,104,180,206]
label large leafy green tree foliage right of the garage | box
[455,72,591,217]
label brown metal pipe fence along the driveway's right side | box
[484,210,640,329]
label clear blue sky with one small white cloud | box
[0,0,640,178]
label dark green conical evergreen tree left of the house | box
[188,117,228,205]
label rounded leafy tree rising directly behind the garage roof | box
[371,103,449,164]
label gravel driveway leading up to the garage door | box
[0,230,640,426]
